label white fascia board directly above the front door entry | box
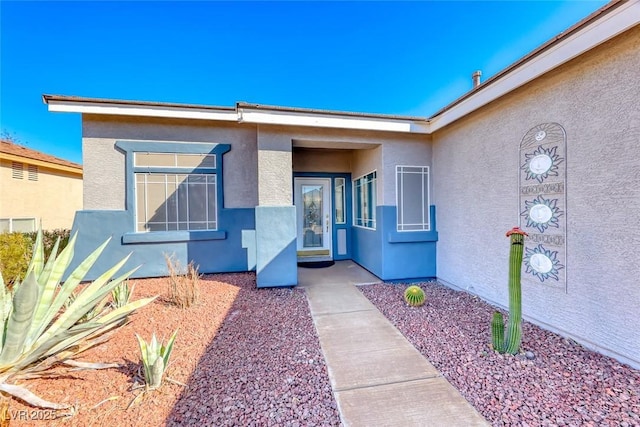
[238,107,429,133]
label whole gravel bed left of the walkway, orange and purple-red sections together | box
[9,273,340,426]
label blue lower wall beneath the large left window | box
[68,208,255,280]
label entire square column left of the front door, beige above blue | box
[256,127,298,288]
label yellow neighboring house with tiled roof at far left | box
[0,140,82,233]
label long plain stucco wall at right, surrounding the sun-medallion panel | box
[433,27,640,365]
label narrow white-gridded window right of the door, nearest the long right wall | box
[396,166,430,231]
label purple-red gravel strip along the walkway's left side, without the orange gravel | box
[167,278,340,426]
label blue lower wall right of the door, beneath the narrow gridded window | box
[352,206,438,280]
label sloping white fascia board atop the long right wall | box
[430,1,640,132]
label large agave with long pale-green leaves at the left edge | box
[0,232,154,409]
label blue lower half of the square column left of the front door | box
[255,206,298,288]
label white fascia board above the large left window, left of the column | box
[47,99,237,122]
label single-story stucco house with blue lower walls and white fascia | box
[44,1,640,367]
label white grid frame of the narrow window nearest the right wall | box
[396,165,431,233]
